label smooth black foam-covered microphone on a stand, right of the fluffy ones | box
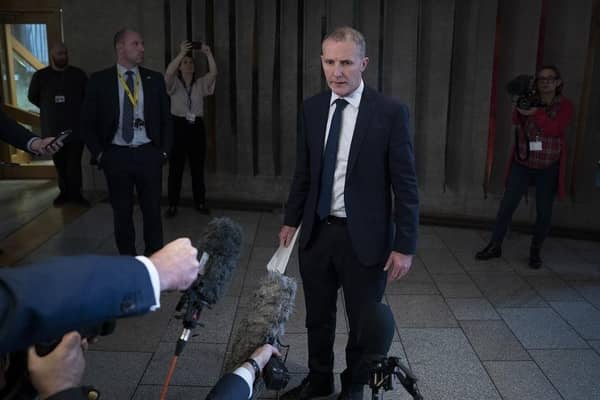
[358,303,423,400]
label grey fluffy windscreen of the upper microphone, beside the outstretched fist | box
[198,217,242,305]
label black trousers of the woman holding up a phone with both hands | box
[169,116,206,207]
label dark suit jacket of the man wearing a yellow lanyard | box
[81,65,173,159]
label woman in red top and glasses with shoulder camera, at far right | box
[475,66,573,269]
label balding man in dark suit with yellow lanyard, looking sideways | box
[82,29,172,255]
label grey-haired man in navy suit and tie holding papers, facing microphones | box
[279,27,419,399]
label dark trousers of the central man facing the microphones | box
[299,222,387,386]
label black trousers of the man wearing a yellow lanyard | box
[101,144,164,255]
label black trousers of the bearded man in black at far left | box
[52,140,83,200]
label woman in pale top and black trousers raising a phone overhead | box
[165,40,217,218]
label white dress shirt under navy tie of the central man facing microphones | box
[323,80,365,218]
